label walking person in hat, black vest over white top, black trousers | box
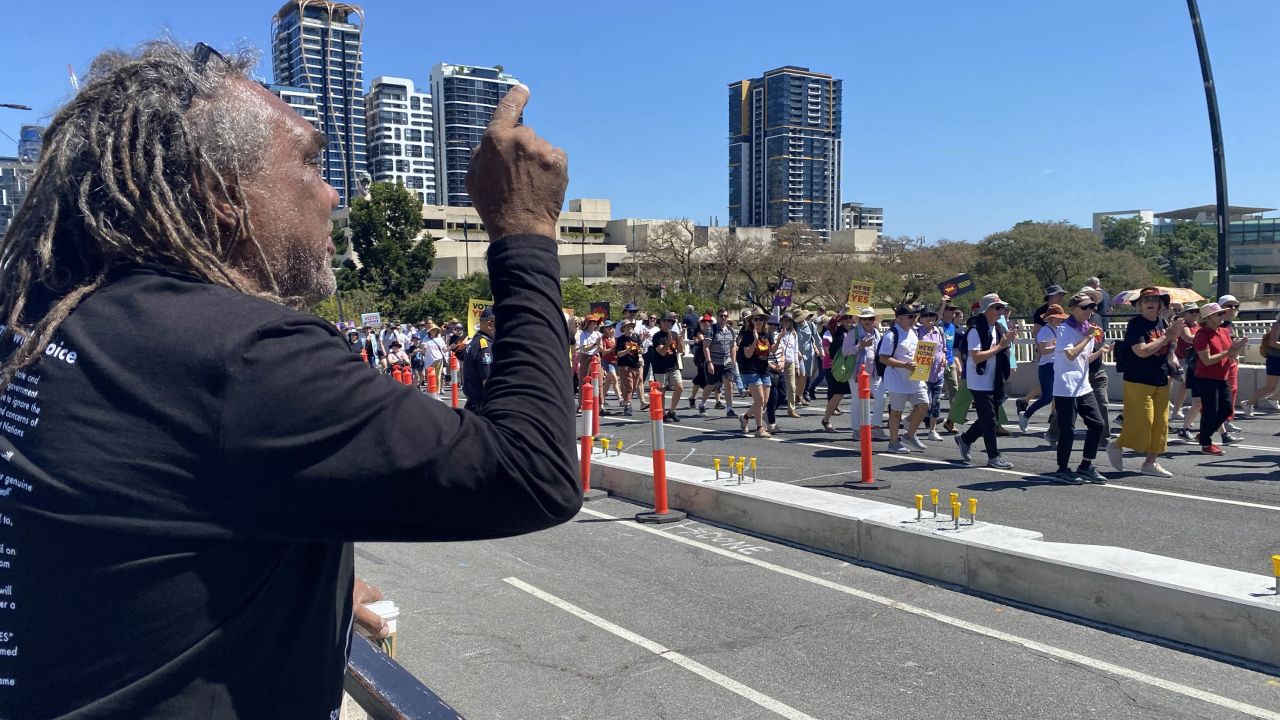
[956,292,1018,470]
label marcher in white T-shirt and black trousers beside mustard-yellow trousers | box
[1044,293,1107,486]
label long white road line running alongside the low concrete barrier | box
[582,509,1280,720]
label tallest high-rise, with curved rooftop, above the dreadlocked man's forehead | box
[271,0,367,205]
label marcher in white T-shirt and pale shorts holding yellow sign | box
[877,305,932,454]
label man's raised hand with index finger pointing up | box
[467,85,568,240]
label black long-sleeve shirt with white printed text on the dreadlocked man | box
[0,237,581,720]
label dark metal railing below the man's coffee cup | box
[343,633,463,720]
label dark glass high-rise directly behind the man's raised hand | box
[431,63,520,206]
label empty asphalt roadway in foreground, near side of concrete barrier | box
[356,497,1280,720]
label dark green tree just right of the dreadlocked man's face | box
[349,182,435,311]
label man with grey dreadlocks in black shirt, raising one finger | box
[0,41,581,719]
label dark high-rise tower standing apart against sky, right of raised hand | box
[728,65,841,238]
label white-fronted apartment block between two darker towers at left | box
[365,76,440,205]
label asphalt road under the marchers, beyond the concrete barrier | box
[588,386,1280,574]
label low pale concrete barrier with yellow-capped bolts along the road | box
[593,454,1280,666]
